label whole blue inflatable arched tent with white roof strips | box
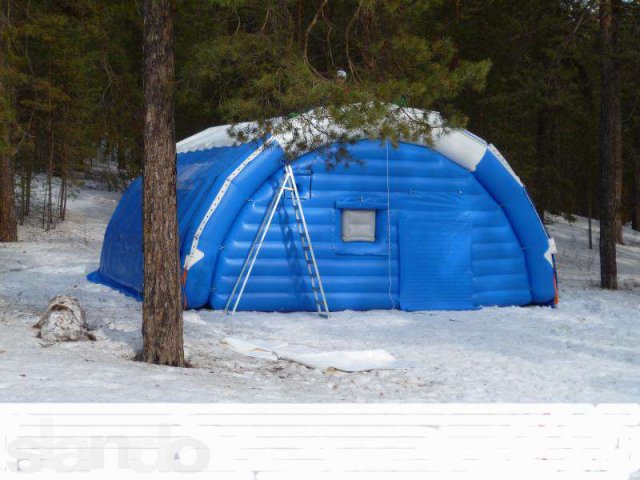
[91,108,557,311]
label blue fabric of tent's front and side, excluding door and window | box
[92,135,554,311]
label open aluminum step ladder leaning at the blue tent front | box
[224,164,329,318]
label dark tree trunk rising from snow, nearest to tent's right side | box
[599,0,622,289]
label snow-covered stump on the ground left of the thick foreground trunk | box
[34,295,96,342]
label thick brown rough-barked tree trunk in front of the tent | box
[142,0,184,366]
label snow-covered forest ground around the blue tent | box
[0,188,640,403]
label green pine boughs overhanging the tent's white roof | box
[176,0,490,158]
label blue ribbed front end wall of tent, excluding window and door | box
[208,140,532,311]
